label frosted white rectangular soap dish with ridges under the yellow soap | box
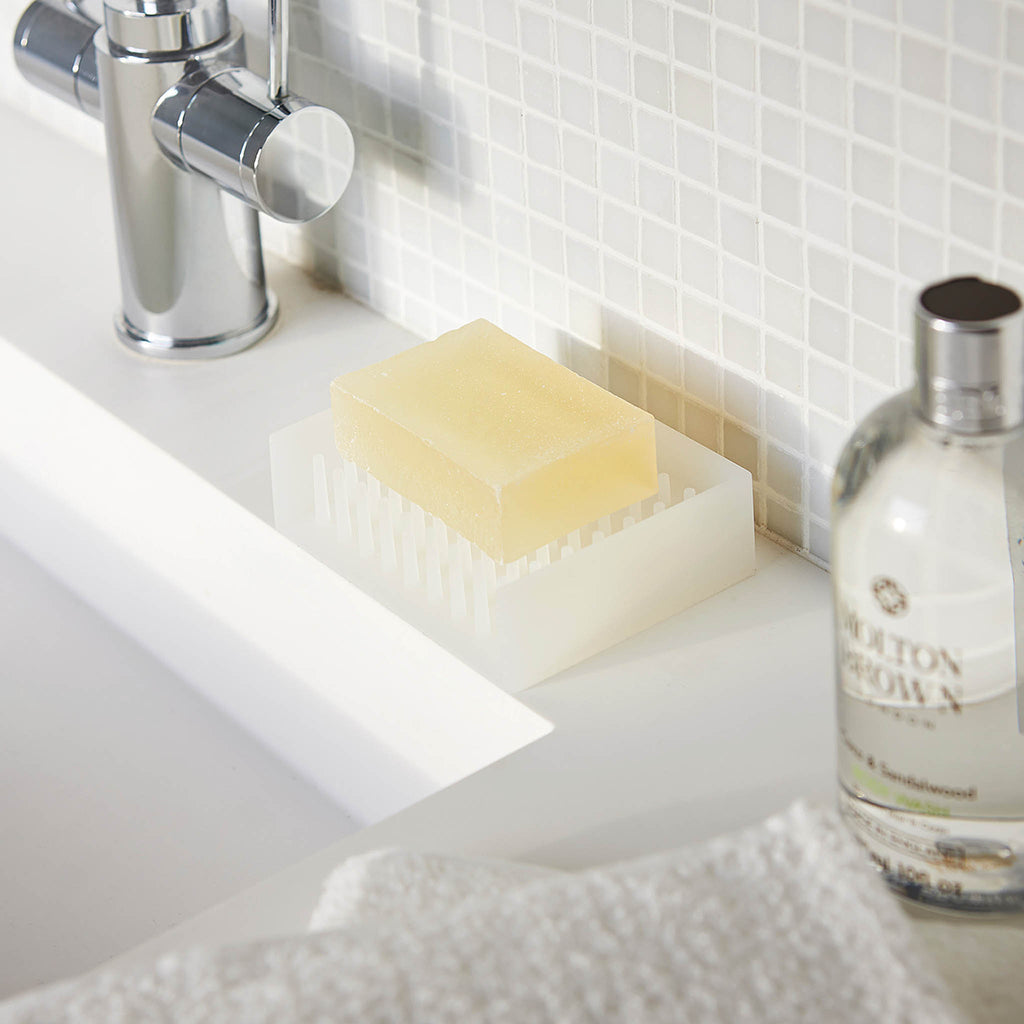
[270,411,754,693]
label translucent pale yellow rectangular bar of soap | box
[331,319,657,562]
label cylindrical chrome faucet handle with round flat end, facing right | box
[152,67,355,223]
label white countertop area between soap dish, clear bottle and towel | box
[114,539,835,962]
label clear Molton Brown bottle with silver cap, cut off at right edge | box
[831,278,1024,911]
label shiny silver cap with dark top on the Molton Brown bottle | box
[914,278,1024,434]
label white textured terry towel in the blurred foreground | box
[0,805,958,1024]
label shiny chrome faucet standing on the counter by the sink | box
[14,0,353,358]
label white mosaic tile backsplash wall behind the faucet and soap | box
[6,0,1024,563]
